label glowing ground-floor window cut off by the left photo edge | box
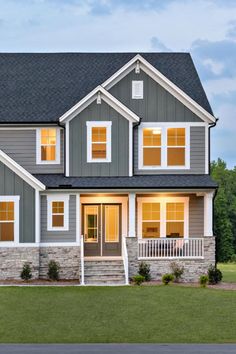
[0,201,15,241]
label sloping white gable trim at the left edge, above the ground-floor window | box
[0,150,46,191]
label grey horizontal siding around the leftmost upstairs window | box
[0,129,64,173]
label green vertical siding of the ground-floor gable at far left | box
[0,162,35,243]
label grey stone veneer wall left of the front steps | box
[0,246,80,280]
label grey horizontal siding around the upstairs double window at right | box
[134,127,207,175]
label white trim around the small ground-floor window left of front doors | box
[47,194,70,231]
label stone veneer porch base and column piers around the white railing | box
[126,237,215,282]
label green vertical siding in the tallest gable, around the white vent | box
[109,70,202,122]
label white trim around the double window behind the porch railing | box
[137,197,189,239]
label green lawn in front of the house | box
[0,285,236,343]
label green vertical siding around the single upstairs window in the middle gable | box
[69,101,129,177]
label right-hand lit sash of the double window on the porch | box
[166,203,184,238]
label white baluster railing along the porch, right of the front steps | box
[138,238,204,259]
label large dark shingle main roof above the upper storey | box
[0,53,212,123]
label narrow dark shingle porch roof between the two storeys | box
[34,174,217,189]
